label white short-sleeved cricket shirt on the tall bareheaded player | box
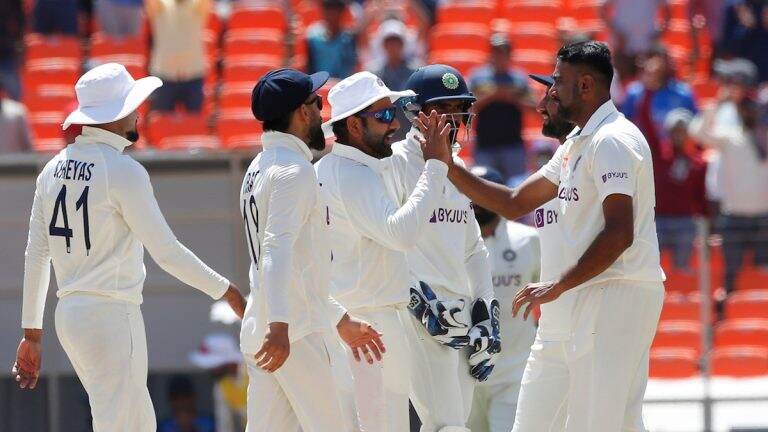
[539,101,664,290]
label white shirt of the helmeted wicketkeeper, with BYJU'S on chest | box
[384,128,493,299]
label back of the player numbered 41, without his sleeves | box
[35,128,148,303]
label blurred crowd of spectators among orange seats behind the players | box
[0,0,768,376]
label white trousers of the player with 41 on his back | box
[56,293,157,432]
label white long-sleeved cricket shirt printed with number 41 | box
[21,126,229,328]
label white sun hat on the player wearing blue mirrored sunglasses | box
[323,72,416,138]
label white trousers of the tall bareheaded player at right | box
[513,281,664,432]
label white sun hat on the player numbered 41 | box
[62,63,163,129]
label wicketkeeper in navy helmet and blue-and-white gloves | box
[385,64,500,432]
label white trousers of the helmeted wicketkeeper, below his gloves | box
[403,286,476,432]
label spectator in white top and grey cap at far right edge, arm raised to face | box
[690,60,768,304]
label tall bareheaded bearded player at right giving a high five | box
[449,41,664,432]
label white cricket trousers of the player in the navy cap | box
[244,333,352,432]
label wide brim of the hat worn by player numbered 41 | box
[61,76,163,129]
